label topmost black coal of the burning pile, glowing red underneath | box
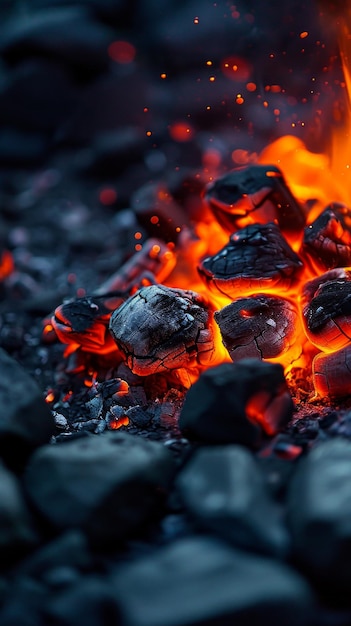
[205,165,305,241]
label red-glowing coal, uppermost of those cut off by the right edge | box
[302,203,351,273]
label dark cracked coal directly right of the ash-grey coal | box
[214,294,301,361]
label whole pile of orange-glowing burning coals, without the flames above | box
[45,138,351,398]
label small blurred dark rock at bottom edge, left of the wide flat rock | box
[47,576,120,626]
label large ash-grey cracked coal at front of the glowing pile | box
[110,285,214,376]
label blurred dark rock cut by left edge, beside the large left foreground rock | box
[0,464,36,562]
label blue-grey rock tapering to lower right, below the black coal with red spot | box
[177,446,289,557]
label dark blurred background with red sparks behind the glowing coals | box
[0,0,346,336]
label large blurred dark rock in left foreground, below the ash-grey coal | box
[25,432,174,544]
